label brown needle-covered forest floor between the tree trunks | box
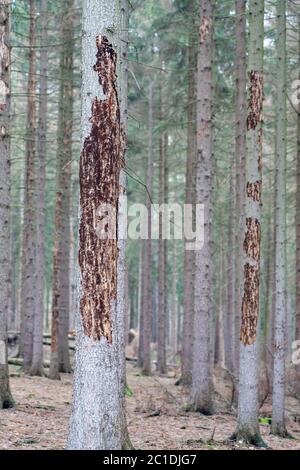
[0,363,300,450]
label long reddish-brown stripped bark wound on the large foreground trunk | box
[79,36,125,343]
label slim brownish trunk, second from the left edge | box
[20,0,36,372]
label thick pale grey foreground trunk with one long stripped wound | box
[68,0,124,450]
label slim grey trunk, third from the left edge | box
[29,0,48,375]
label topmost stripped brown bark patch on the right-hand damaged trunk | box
[247,70,263,131]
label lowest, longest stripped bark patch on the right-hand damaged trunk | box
[240,263,259,346]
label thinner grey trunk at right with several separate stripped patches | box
[235,0,264,445]
